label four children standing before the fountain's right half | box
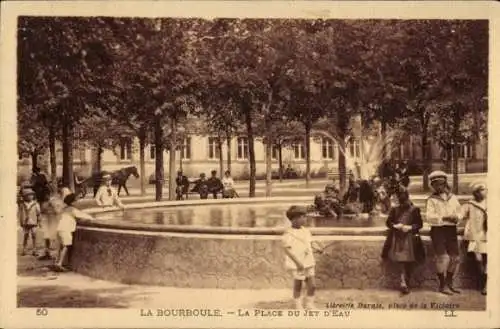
[282,171,487,309]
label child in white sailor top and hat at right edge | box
[463,183,488,295]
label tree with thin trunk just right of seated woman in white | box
[198,19,274,197]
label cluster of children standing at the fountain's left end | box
[18,187,92,272]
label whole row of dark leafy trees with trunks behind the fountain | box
[18,17,488,200]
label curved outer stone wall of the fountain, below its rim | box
[72,226,475,289]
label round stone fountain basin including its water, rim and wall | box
[72,197,472,289]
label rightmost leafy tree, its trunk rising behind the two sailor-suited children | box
[426,21,488,193]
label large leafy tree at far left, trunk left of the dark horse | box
[18,17,112,189]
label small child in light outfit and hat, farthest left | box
[18,189,40,256]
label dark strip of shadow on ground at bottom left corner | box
[17,285,130,308]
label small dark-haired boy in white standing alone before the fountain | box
[283,206,316,309]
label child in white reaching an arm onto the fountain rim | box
[55,193,93,272]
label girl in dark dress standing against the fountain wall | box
[382,187,425,294]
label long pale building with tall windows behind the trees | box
[18,114,487,179]
